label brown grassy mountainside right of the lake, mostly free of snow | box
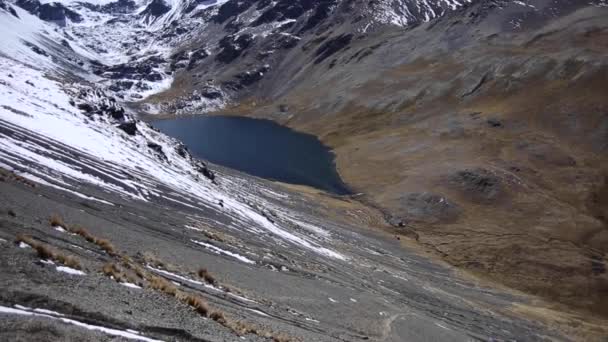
[216,1,608,315]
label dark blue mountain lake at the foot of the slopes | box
[153,116,349,195]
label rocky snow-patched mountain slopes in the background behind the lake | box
[3,0,484,113]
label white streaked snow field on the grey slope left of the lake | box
[0,50,345,259]
